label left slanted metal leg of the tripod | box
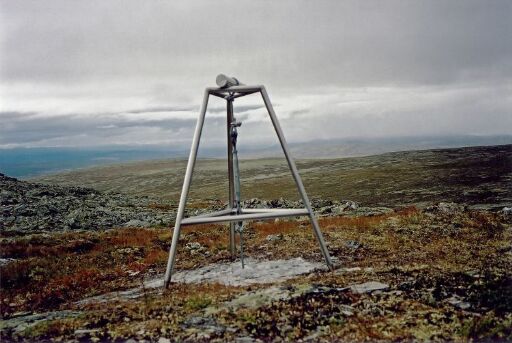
[164,90,210,288]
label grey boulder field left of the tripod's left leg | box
[0,174,174,233]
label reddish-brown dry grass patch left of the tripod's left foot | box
[0,229,169,314]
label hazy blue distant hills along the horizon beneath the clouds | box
[0,135,512,178]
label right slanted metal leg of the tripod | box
[261,86,334,270]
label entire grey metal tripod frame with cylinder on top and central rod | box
[164,74,333,288]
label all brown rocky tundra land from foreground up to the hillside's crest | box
[0,146,512,343]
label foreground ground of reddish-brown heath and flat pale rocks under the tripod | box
[0,203,512,342]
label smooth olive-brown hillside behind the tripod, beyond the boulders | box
[37,144,512,208]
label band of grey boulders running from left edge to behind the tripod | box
[0,174,390,234]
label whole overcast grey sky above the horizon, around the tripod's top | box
[0,0,512,148]
